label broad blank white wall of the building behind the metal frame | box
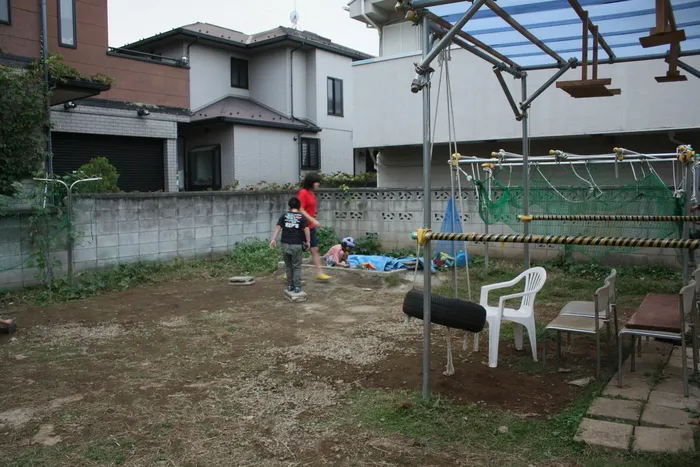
[353,49,700,148]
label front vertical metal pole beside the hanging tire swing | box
[421,16,432,401]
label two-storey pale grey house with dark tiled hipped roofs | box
[123,23,371,191]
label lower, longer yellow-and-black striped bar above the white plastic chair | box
[414,231,700,250]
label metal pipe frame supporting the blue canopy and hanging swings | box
[396,0,700,400]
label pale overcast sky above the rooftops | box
[109,0,379,55]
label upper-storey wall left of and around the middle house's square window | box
[190,44,253,111]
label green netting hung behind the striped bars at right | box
[476,164,684,259]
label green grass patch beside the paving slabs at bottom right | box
[347,383,700,467]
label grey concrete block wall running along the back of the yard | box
[0,188,678,288]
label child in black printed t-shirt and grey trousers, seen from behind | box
[270,197,311,293]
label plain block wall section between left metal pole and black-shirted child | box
[69,192,289,271]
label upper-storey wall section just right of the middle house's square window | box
[249,48,290,116]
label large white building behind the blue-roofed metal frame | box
[348,0,700,187]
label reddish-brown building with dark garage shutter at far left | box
[0,0,189,191]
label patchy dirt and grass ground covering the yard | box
[0,258,700,467]
